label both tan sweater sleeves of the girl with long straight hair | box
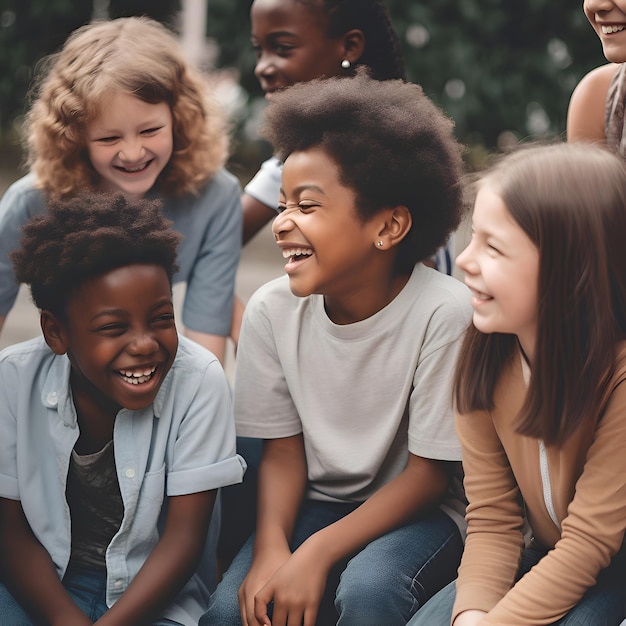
[454,376,626,626]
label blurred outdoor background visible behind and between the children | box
[0,0,605,360]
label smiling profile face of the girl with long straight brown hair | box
[456,184,539,359]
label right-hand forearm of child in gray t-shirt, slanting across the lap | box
[309,454,448,565]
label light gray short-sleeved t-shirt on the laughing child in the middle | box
[235,264,471,512]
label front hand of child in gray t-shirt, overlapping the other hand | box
[254,541,332,626]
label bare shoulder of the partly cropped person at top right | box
[567,63,619,143]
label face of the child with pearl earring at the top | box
[250,0,345,94]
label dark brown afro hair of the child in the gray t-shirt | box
[262,69,465,271]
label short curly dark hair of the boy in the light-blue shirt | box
[10,193,182,318]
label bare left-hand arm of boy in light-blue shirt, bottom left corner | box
[0,498,92,626]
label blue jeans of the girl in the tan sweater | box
[407,548,626,626]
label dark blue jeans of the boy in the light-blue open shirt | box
[0,570,182,626]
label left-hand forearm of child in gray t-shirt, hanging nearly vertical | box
[255,435,307,554]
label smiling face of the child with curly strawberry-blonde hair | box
[87,93,174,198]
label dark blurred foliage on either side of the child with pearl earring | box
[207,0,606,161]
